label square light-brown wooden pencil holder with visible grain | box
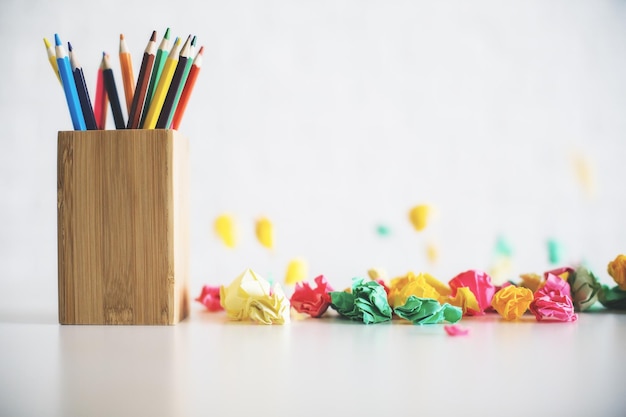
[57,129,189,325]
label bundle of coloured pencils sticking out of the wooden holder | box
[43,28,204,130]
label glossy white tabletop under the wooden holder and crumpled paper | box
[0,306,626,416]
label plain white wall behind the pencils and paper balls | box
[0,0,626,310]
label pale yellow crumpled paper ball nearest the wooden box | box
[220,269,290,324]
